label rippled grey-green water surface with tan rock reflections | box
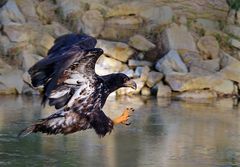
[0,96,240,167]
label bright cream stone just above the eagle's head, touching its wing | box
[97,55,123,72]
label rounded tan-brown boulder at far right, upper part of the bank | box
[197,36,219,60]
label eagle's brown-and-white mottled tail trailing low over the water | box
[18,111,90,137]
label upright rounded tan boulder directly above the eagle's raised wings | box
[82,10,104,37]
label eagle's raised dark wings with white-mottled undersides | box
[29,34,103,108]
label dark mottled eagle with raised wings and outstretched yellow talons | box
[18,33,137,137]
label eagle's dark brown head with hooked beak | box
[102,73,137,92]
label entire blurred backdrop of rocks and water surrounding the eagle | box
[0,0,240,167]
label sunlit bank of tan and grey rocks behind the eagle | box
[0,0,240,98]
